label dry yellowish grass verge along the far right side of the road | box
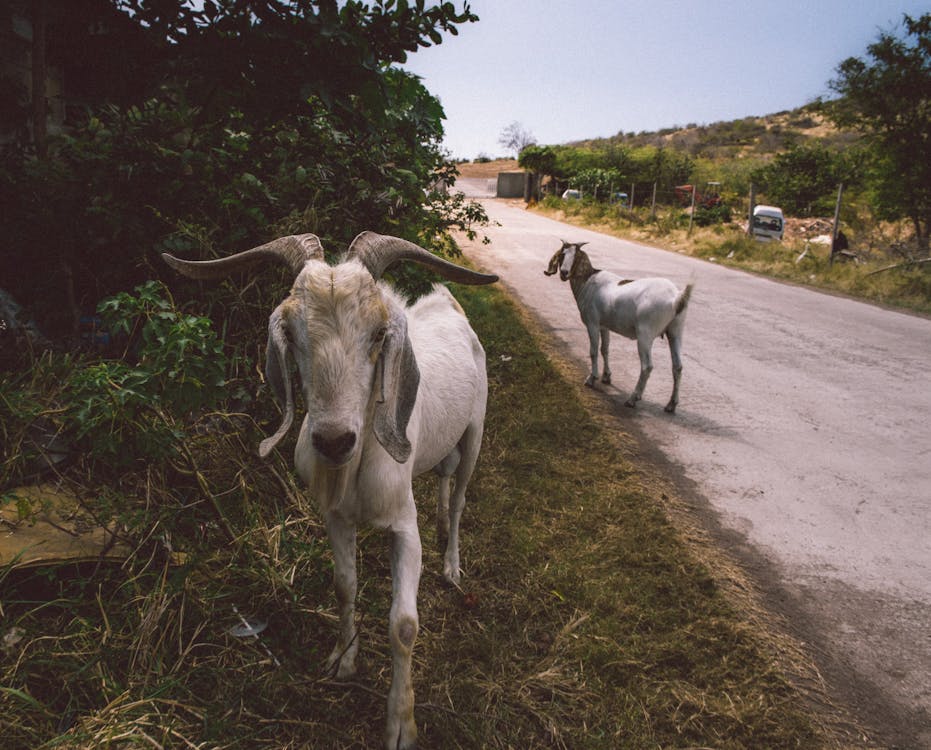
[533,199,931,315]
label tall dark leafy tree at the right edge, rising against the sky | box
[830,13,931,252]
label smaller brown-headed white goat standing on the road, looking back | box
[543,240,692,413]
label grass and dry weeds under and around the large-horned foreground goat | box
[0,288,856,750]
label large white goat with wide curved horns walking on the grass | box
[164,232,497,750]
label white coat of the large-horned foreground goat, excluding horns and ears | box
[284,262,487,748]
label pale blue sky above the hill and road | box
[402,0,931,159]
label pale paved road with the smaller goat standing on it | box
[458,199,931,748]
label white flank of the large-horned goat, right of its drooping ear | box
[408,286,488,475]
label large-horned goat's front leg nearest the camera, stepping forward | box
[385,520,421,750]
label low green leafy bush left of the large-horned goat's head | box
[0,281,228,484]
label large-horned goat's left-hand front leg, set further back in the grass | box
[326,513,359,679]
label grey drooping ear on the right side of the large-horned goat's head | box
[374,310,420,464]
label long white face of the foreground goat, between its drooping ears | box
[273,263,389,466]
